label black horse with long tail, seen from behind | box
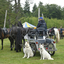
[10,22,26,52]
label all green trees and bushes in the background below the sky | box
[0,0,64,28]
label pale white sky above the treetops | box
[12,0,64,11]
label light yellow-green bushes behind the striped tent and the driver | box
[20,17,64,28]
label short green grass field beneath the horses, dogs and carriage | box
[0,39,64,64]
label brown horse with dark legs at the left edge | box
[0,25,23,50]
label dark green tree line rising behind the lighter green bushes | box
[0,0,64,27]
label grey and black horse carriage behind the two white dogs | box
[23,28,57,55]
